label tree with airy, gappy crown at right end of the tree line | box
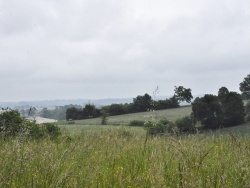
[174,86,193,103]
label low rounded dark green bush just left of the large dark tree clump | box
[175,116,195,133]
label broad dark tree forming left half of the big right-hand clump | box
[192,95,223,129]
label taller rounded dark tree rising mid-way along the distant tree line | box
[133,93,152,112]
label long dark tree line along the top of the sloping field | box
[61,86,193,120]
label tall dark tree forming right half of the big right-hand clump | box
[219,91,246,127]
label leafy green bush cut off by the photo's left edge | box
[0,109,25,136]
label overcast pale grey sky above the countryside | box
[0,0,250,102]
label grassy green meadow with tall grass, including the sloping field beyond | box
[0,107,250,188]
